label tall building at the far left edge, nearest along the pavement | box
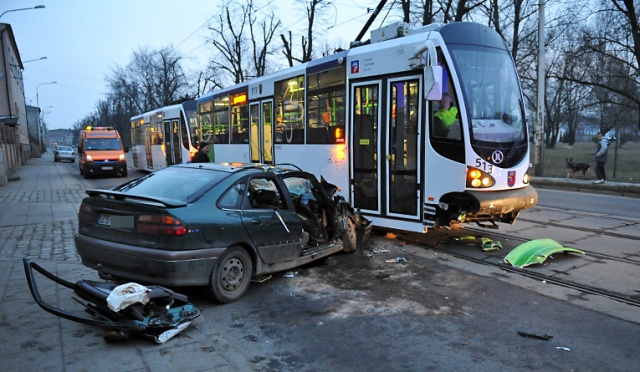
[0,23,31,186]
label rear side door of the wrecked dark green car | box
[242,174,302,263]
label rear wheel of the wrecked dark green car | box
[207,247,253,304]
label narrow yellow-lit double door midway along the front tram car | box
[249,100,275,164]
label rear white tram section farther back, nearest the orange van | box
[130,100,201,172]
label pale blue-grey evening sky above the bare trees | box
[0,0,384,130]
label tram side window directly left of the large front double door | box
[307,67,346,144]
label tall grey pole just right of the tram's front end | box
[533,0,546,177]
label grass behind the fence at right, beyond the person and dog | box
[531,142,640,183]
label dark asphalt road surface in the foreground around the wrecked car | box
[5,158,640,372]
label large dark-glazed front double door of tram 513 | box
[351,77,421,218]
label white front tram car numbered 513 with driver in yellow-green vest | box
[197,22,538,232]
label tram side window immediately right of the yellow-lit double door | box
[274,75,304,144]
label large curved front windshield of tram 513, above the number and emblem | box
[450,45,527,166]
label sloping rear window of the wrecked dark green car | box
[114,167,229,202]
